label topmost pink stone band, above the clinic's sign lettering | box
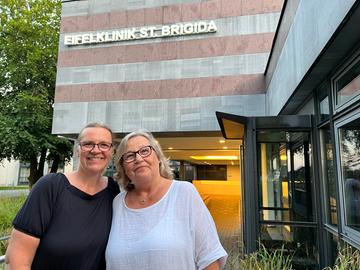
[60,0,284,33]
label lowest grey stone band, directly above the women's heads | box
[53,94,265,134]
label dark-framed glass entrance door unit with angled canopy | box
[217,112,319,269]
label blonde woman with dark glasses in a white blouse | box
[105,131,227,270]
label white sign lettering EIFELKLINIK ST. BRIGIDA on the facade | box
[64,21,217,46]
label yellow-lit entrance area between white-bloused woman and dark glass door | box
[155,136,242,253]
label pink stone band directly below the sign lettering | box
[58,33,274,67]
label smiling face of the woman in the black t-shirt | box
[78,127,112,174]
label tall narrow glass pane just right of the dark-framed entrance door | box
[320,126,337,225]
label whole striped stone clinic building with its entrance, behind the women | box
[53,0,360,269]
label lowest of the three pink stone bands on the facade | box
[55,74,265,102]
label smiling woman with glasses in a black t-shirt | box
[5,123,119,270]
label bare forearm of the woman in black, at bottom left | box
[5,229,40,270]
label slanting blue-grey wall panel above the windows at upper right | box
[266,0,356,115]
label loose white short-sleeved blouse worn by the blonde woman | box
[105,180,227,270]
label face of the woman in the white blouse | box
[123,136,160,184]
